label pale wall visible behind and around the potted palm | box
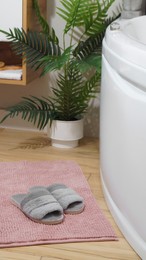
[0,0,122,136]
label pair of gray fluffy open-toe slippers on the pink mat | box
[11,184,85,224]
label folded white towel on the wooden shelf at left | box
[0,69,22,80]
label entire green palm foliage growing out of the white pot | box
[0,0,118,147]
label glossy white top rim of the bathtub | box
[104,15,146,69]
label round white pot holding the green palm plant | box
[48,119,83,148]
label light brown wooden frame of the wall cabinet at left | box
[0,0,47,86]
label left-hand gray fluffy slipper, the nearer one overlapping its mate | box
[11,189,64,224]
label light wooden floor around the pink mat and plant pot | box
[0,129,140,260]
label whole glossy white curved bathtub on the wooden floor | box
[100,16,146,260]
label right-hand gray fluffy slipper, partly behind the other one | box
[30,183,85,214]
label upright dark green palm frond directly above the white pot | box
[50,64,100,121]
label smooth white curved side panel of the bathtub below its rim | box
[100,57,146,244]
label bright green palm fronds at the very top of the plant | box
[58,0,115,36]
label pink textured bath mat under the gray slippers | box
[0,161,117,247]
